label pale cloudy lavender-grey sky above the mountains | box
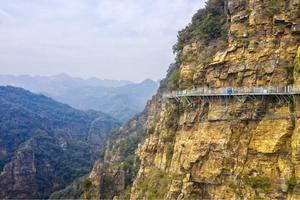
[0,0,204,81]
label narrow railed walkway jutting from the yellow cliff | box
[163,85,300,98]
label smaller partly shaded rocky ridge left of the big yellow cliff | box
[50,88,163,199]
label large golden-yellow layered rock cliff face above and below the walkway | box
[131,0,300,199]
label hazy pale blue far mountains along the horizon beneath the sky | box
[0,74,158,122]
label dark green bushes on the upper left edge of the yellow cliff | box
[167,0,228,91]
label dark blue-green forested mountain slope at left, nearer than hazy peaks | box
[0,87,120,199]
